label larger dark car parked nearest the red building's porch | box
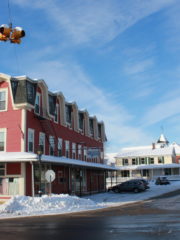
[108,180,146,193]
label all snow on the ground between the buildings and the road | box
[0,181,180,218]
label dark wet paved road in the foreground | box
[0,193,180,240]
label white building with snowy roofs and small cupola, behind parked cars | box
[115,134,180,179]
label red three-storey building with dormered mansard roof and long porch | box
[0,74,113,197]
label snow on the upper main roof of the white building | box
[116,146,174,158]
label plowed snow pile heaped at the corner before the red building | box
[0,194,103,216]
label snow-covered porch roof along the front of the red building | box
[0,152,116,170]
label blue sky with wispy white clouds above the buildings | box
[0,0,180,152]
